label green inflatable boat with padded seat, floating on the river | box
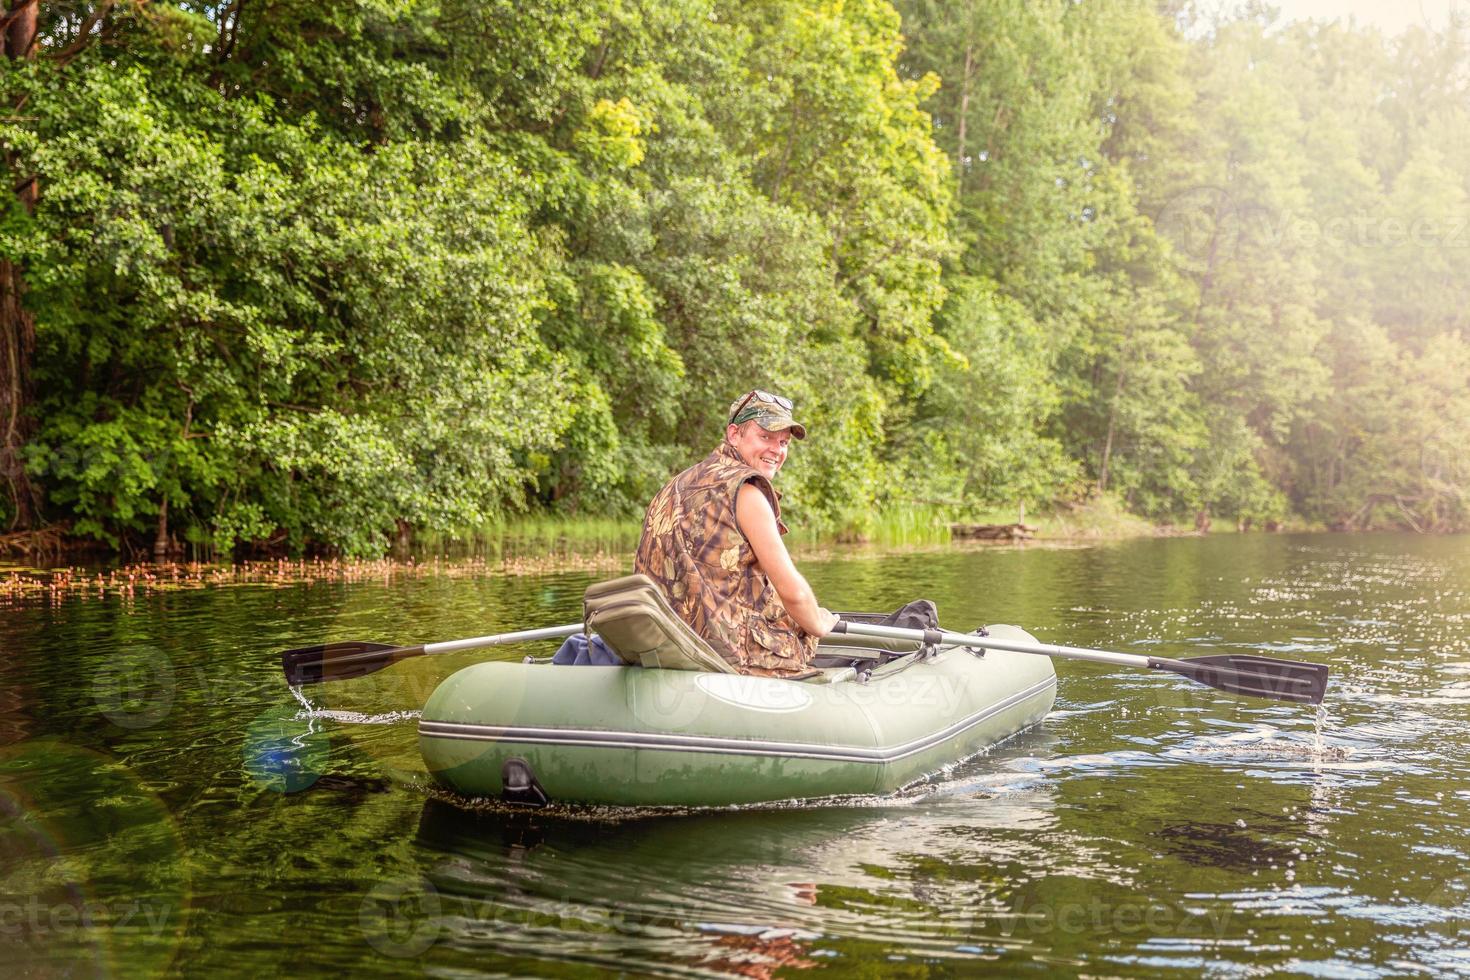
[419,576,1057,807]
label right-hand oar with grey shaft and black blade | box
[832,620,1327,704]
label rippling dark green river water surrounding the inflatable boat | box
[0,535,1470,977]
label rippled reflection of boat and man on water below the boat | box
[410,760,1066,976]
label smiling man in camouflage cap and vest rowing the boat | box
[634,388,838,677]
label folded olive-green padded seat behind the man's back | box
[582,574,739,674]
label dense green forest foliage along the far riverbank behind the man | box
[0,0,1470,554]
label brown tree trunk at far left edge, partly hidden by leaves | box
[0,0,40,529]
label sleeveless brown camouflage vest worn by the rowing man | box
[634,444,817,677]
